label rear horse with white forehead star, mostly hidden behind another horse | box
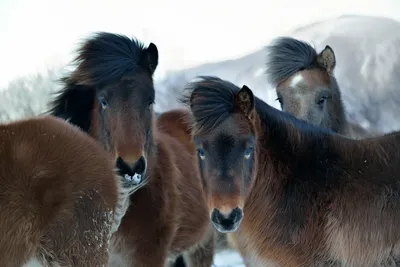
[266,37,378,139]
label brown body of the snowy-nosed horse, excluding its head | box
[110,110,214,267]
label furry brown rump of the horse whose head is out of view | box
[0,116,141,267]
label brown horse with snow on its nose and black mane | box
[47,32,214,267]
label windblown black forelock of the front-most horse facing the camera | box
[181,76,240,134]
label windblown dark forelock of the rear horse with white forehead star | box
[266,37,317,86]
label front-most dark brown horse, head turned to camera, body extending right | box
[181,76,400,267]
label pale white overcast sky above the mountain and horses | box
[0,0,400,87]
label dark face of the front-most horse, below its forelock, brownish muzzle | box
[194,87,255,233]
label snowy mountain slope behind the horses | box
[156,16,400,132]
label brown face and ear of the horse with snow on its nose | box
[96,45,158,181]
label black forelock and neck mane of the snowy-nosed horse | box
[47,32,146,131]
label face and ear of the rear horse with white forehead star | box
[276,46,344,131]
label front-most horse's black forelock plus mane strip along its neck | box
[180,76,336,135]
